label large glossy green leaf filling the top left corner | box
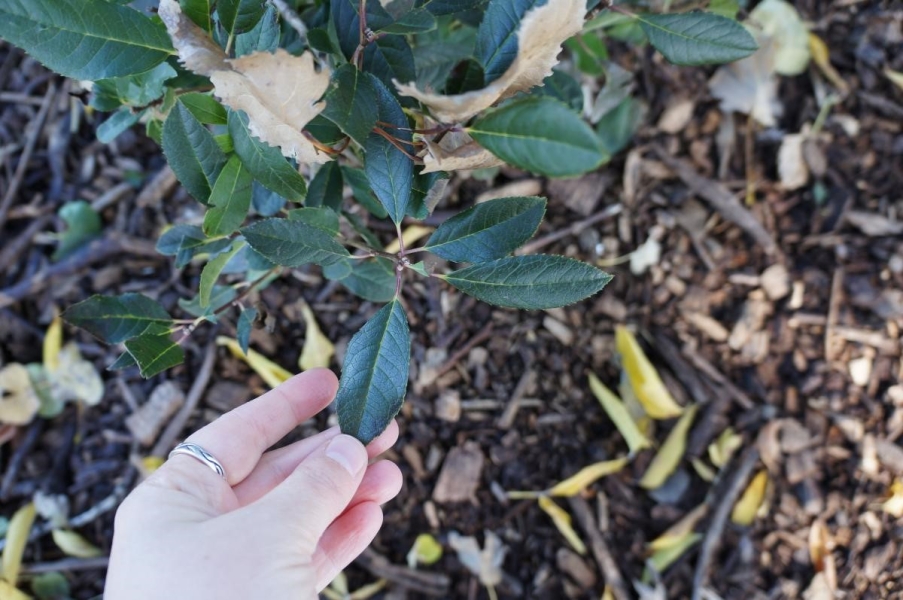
[0,0,172,80]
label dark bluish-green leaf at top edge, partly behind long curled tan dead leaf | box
[475,0,548,84]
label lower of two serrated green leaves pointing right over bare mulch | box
[443,255,611,310]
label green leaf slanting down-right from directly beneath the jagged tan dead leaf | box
[229,111,308,202]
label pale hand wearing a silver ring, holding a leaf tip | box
[104,369,402,600]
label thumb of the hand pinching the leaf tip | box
[256,434,367,552]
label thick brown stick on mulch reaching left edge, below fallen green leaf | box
[0,234,163,308]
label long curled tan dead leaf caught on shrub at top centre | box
[395,0,586,123]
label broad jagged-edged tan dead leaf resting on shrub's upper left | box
[158,0,332,163]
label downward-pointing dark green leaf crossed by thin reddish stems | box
[364,78,414,224]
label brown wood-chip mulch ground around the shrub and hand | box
[0,0,903,599]
